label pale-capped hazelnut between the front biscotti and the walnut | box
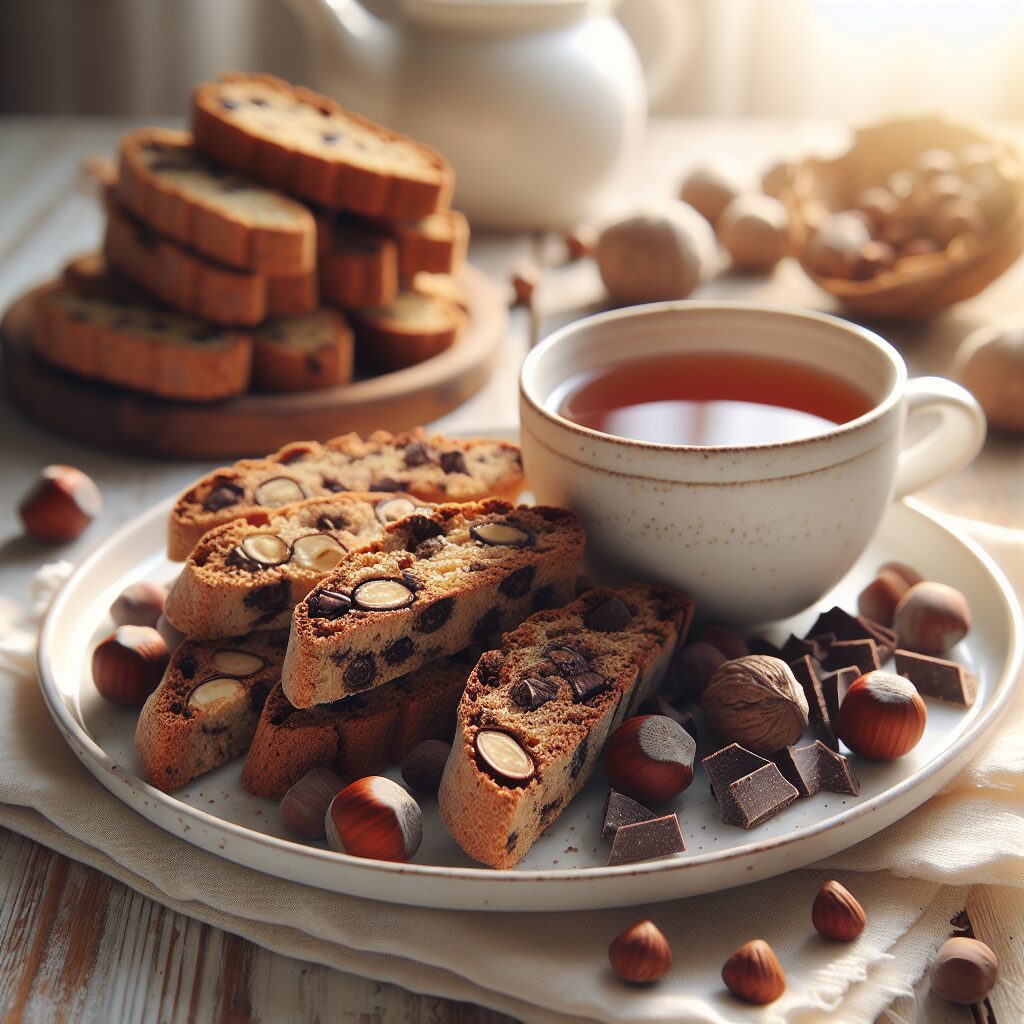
[603,715,696,804]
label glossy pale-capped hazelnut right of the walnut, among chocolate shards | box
[836,671,928,761]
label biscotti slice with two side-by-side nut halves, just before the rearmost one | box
[164,494,412,637]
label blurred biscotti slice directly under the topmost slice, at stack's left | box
[115,128,316,274]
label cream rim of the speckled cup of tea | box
[519,299,907,454]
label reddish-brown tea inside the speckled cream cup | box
[557,352,873,447]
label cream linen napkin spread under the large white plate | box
[0,520,1024,1024]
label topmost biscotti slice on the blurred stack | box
[193,74,454,220]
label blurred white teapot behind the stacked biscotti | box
[278,0,686,228]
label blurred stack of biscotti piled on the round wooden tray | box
[37,74,469,401]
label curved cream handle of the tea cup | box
[893,377,985,498]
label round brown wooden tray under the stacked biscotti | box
[0,266,508,459]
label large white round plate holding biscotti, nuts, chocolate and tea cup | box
[39,491,1022,910]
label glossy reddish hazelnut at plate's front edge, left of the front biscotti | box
[324,775,423,861]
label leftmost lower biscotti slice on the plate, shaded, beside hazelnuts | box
[135,630,288,793]
